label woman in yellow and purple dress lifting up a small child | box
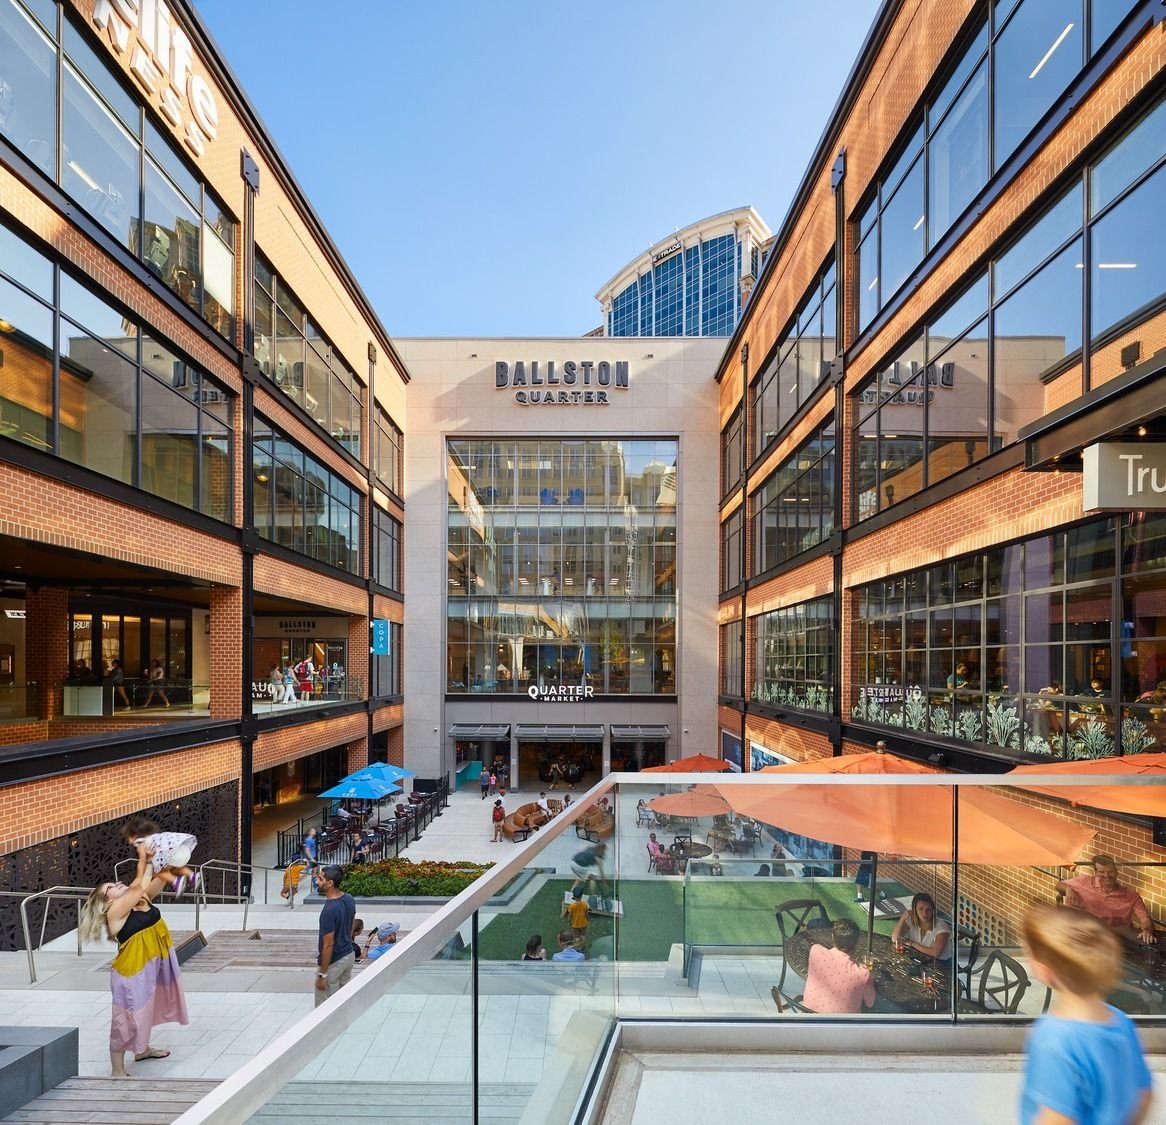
[80,845,190,1078]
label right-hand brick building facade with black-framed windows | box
[717,0,1166,942]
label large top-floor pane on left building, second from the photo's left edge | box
[61,63,139,254]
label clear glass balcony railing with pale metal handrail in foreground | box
[170,774,1166,1125]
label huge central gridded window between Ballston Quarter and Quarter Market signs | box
[447,440,677,695]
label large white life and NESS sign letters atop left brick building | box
[93,0,218,156]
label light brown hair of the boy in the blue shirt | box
[1020,902,1122,996]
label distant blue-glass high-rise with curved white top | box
[592,208,770,336]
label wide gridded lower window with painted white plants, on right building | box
[851,513,1166,758]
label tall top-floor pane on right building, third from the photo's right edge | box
[927,61,988,246]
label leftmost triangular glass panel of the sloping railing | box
[239,908,475,1125]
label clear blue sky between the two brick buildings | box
[196,0,877,336]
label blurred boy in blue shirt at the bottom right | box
[1020,903,1152,1125]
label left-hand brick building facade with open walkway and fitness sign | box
[0,0,408,944]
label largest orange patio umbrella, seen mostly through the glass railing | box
[719,754,1094,866]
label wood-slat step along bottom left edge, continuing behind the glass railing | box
[2,1077,534,1125]
